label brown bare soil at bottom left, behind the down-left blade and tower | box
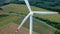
[0,23,37,34]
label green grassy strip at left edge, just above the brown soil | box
[0,16,20,27]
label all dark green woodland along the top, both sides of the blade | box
[0,0,60,11]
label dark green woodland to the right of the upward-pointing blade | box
[30,0,60,11]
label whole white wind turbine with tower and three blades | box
[14,0,60,34]
